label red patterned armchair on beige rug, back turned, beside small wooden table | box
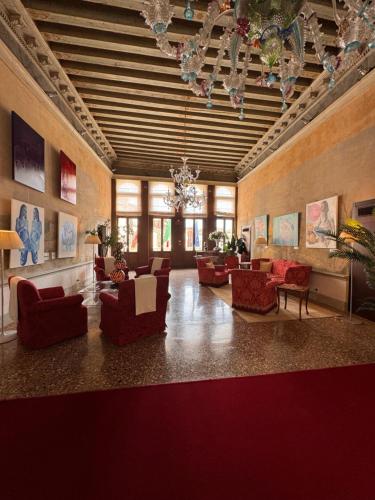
[232,269,277,314]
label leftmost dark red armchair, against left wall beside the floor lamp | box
[9,277,87,349]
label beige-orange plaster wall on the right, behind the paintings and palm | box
[237,72,375,308]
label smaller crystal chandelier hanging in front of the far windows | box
[164,156,206,211]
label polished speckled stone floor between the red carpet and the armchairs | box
[0,270,375,399]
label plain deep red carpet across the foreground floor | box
[0,365,375,500]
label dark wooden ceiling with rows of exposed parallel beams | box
[22,0,337,180]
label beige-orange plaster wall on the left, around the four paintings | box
[0,46,111,276]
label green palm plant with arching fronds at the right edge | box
[319,219,375,311]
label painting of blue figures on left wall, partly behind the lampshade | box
[9,200,44,267]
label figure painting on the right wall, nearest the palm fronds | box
[306,196,339,248]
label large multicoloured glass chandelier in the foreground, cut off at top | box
[142,0,375,120]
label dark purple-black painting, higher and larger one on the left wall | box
[12,111,45,193]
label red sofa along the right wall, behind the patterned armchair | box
[251,259,312,286]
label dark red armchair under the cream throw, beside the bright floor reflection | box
[100,276,170,345]
